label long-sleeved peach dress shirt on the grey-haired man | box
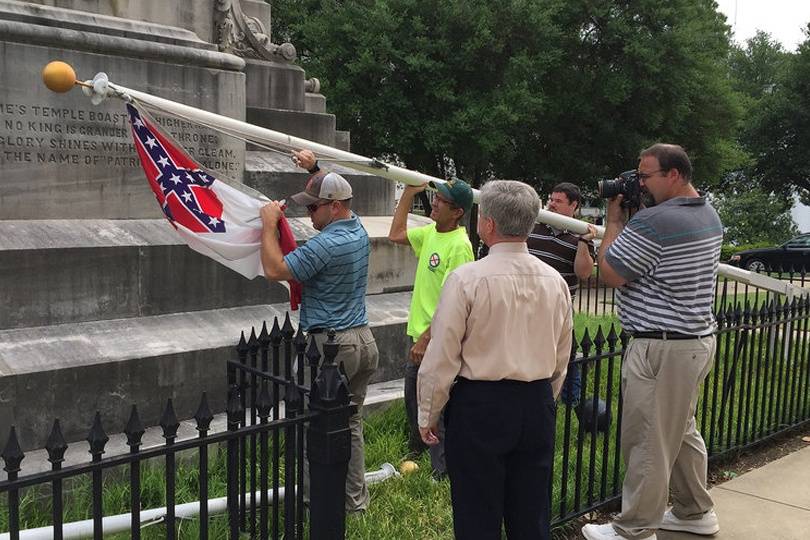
[417,242,573,427]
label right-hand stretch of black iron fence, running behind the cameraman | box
[553,271,810,525]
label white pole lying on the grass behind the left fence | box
[0,463,399,540]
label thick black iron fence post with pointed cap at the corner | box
[307,331,352,540]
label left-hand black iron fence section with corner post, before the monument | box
[0,316,354,540]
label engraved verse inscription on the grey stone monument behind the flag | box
[0,100,242,178]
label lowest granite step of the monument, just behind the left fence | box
[0,292,411,449]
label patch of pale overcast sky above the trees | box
[715,0,810,51]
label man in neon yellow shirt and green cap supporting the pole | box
[388,179,473,475]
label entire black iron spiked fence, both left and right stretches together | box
[0,272,810,539]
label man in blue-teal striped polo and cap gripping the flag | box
[261,151,379,512]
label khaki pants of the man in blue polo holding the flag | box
[304,326,380,512]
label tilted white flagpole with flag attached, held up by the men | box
[82,75,807,298]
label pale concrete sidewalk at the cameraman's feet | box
[657,447,810,540]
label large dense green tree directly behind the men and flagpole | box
[273,0,741,194]
